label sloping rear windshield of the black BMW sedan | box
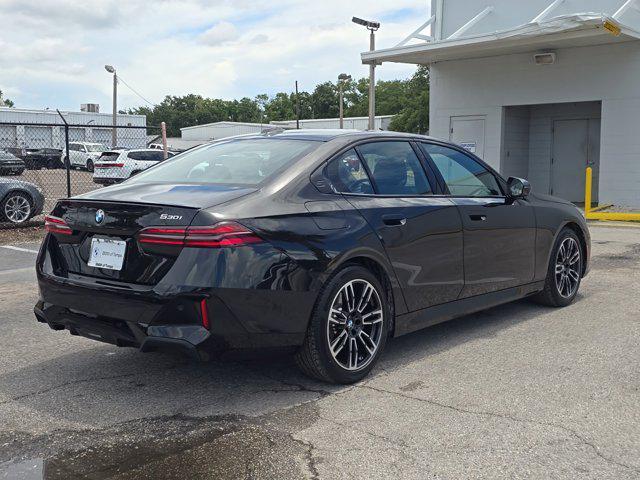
[128,138,320,185]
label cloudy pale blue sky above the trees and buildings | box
[0,0,430,112]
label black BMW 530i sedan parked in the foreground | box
[35,130,590,383]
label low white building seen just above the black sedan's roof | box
[180,115,393,146]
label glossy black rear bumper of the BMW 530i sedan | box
[34,272,304,360]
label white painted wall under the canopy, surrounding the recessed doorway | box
[430,42,640,206]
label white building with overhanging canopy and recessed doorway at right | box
[362,0,640,207]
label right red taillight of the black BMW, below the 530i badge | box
[138,222,263,248]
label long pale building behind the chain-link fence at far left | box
[0,104,147,149]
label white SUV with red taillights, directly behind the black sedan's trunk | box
[93,148,174,185]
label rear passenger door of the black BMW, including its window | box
[327,140,464,311]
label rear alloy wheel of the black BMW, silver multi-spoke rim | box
[327,279,384,371]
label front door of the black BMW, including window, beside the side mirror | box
[420,143,536,298]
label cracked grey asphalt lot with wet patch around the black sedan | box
[0,225,640,479]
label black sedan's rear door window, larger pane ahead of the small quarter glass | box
[358,142,433,195]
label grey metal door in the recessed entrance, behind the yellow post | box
[550,118,600,203]
